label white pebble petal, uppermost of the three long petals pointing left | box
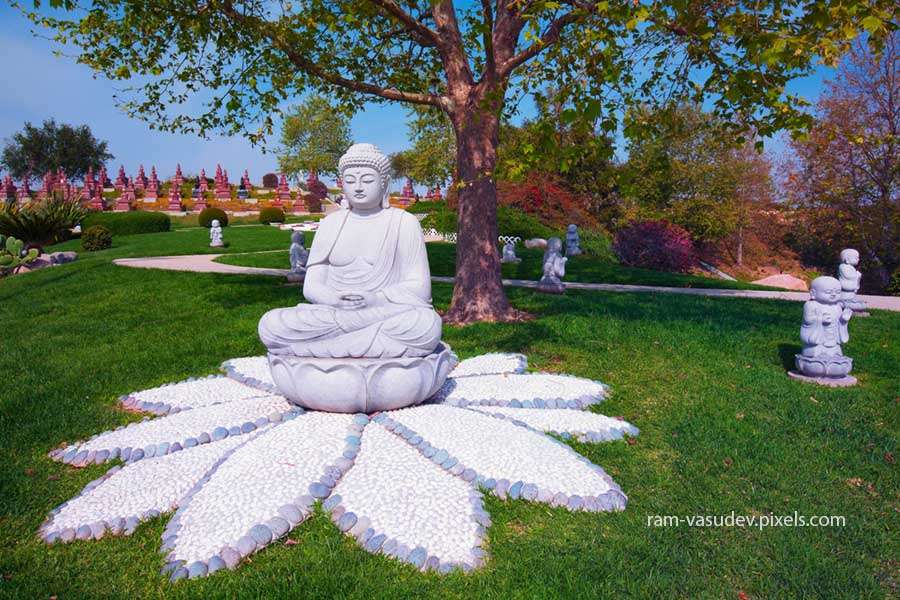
[127,377,268,414]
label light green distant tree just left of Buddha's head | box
[277,95,352,180]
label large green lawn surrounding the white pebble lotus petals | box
[0,227,900,599]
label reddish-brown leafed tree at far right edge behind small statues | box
[785,33,900,290]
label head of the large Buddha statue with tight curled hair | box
[338,144,391,210]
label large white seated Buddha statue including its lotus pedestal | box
[258,144,456,412]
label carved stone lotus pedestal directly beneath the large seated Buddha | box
[269,342,459,414]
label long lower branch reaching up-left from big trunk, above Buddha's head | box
[222,0,443,107]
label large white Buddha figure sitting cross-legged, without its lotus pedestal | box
[259,144,441,358]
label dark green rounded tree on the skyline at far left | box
[0,119,114,179]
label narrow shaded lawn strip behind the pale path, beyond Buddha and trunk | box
[217,243,777,290]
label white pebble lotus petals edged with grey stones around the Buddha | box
[40,353,638,581]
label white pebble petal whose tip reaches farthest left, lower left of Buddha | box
[46,436,250,533]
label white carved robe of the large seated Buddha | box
[259,208,441,358]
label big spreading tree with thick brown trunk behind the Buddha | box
[21,0,896,324]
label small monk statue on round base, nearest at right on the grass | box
[790,276,856,385]
